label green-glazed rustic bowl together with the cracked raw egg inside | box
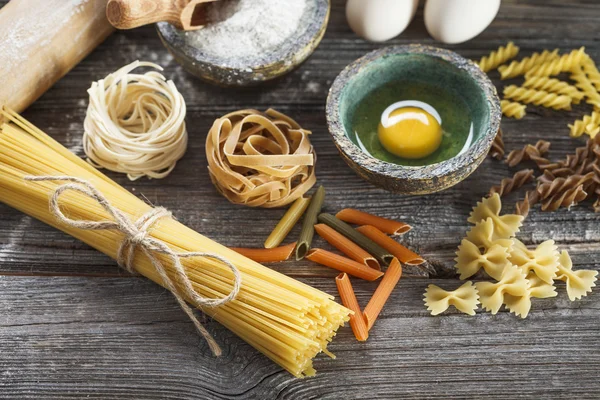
[327,45,501,194]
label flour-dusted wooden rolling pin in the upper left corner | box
[0,0,114,112]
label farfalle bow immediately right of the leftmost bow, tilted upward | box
[475,265,529,314]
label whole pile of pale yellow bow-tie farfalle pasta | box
[424,193,598,318]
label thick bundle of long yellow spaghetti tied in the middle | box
[0,110,350,377]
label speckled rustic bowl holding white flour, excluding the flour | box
[156,0,330,86]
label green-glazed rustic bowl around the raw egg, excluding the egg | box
[327,45,502,194]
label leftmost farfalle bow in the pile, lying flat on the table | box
[423,282,479,315]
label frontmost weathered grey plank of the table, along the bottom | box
[0,277,600,399]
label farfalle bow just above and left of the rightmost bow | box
[509,239,558,284]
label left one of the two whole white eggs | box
[346,0,419,42]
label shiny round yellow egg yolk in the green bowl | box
[377,107,442,159]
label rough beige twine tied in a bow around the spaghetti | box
[25,176,242,356]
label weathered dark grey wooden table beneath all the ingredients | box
[0,0,600,399]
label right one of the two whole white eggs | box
[425,0,500,44]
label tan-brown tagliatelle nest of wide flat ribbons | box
[206,109,316,208]
